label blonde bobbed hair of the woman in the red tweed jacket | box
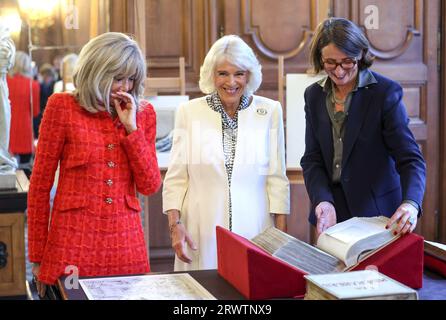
[73,32,146,113]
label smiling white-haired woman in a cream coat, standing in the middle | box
[163,35,289,271]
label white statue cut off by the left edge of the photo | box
[0,22,17,174]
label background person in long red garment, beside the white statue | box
[6,51,40,170]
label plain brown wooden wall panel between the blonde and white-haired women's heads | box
[145,0,216,96]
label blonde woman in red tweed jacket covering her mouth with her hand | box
[28,32,161,296]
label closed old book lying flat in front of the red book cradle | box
[304,270,418,300]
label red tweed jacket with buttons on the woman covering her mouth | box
[28,93,161,284]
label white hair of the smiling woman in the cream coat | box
[199,35,262,97]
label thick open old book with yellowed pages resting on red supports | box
[251,216,398,274]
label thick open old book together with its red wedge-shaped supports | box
[216,218,423,299]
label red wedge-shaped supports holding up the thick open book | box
[216,226,424,299]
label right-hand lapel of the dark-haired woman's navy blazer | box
[342,87,373,167]
